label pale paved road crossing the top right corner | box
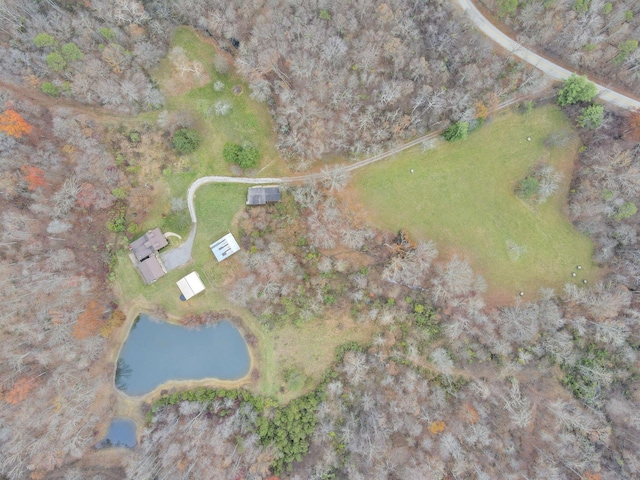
[454,0,640,110]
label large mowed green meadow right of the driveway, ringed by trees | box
[354,106,598,300]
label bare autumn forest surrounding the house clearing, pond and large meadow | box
[0,0,640,480]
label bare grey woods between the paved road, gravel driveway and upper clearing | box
[172,0,540,169]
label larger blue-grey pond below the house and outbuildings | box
[116,314,251,396]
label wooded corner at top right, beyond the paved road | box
[478,0,640,96]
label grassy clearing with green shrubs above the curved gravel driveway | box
[137,27,290,238]
